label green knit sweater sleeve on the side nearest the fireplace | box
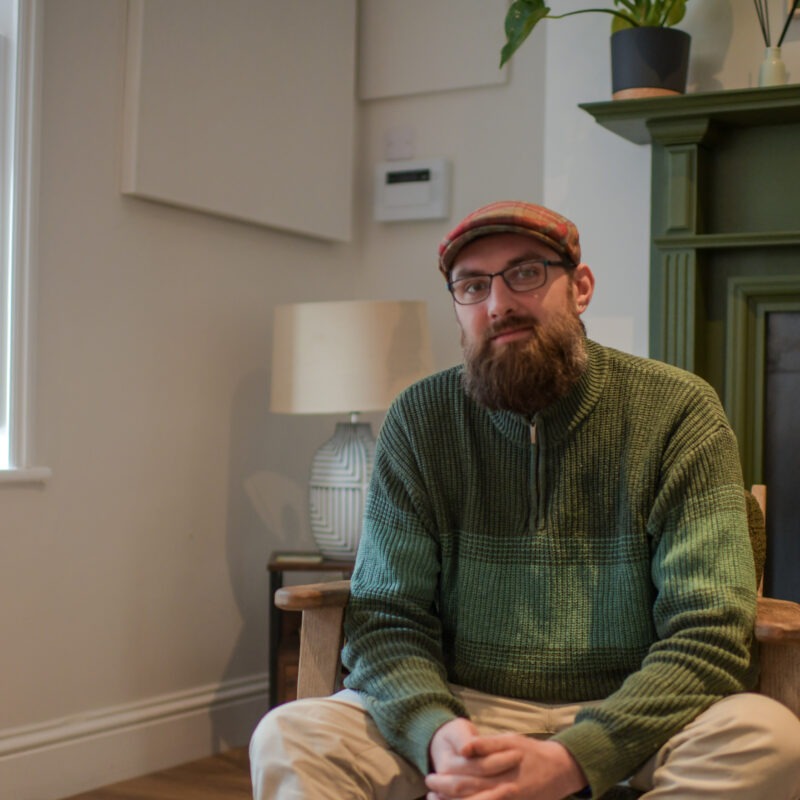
[555,421,756,797]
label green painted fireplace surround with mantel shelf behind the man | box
[581,85,800,600]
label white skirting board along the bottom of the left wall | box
[0,674,269,800]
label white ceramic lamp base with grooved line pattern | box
[309,422,375,558]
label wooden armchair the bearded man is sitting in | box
[275,485,800,716]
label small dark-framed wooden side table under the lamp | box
[267,552,355,708]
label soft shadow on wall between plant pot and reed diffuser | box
[680,0,736,92]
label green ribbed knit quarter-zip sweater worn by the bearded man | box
[344,341,755,797]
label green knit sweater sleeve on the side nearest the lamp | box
[342,410,467,773]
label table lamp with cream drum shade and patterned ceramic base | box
[270,300,433,559]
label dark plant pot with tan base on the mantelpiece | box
[611,27,691,100]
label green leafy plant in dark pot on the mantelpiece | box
[500,0,690,99]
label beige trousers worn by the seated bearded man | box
[250,686,800,800]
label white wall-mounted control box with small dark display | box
[374,158,450,222]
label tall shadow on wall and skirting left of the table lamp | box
[211,371,324,751]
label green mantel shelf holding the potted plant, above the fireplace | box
[580,84,800,144]
